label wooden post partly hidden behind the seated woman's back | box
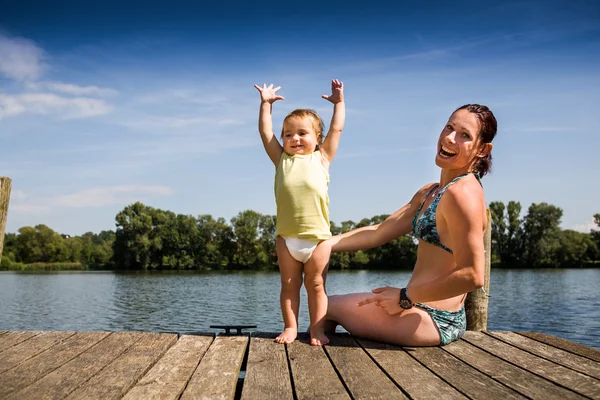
[465,208,492,331]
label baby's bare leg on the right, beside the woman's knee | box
[304,245,330,346]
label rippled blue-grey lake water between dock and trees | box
[0,269,600,349]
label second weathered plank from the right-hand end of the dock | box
[489,331,600,383]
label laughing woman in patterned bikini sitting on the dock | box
[326,104,497,346]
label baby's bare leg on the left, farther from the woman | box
[275,237,302,343]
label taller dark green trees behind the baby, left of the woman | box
[113,203,416,269]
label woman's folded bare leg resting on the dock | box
[327,293,440,346]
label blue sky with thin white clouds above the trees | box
[0,1,600,235]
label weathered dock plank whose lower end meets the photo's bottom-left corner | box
[0,332,106,398]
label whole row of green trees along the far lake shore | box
[0,201,600,270]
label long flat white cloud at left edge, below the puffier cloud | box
[0,93,112,119]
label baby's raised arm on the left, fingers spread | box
[254,83,283,167]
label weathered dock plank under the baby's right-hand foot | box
[287,334,350,400]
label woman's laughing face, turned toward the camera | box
[435,109,491,172]
